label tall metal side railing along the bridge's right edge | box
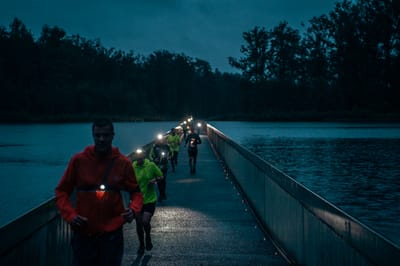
[207,125,400,266]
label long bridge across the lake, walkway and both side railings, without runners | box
[0,125,400,265]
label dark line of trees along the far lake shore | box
[0,0,400,122]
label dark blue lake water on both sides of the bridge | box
[0,121,400,243]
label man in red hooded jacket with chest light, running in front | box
[55,120,143,265]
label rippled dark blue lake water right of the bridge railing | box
[211,122,400,244]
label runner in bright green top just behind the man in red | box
[132,149,163,255]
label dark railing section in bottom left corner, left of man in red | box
[0,198,72,266]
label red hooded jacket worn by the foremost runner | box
[55,145,143,235]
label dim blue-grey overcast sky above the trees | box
[0,0,337,72]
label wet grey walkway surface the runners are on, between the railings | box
[123,135,288,265]
